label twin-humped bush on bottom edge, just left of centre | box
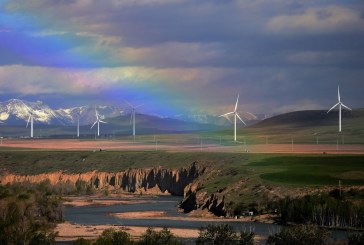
[137,227,182,245]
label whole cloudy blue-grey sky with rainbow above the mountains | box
[0,0,364,115]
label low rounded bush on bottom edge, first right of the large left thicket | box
[95,229,134,245]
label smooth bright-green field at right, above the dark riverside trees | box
[251,155,364,185]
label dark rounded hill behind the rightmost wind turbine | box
[238,109,364,144]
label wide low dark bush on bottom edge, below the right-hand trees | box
[267,225,329,245]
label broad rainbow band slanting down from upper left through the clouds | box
[0,1,193,115]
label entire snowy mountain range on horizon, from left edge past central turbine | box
[0,99,260,126]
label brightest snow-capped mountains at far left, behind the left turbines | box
[0,99,121,125]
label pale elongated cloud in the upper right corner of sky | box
[266,5,364,35]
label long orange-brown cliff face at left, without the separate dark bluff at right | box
[0,163,205,196]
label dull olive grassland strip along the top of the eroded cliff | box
[0,151,249,174]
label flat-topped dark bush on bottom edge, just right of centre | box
[196,224,238,245]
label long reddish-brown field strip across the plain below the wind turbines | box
[0,139,364,154]
